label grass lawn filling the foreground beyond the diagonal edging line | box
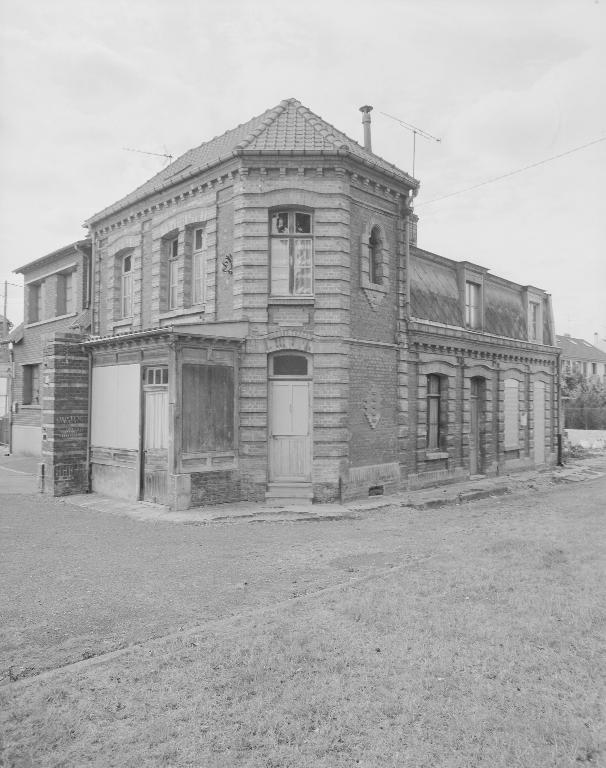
[0,486,606,768]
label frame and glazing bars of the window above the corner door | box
[268,205,315,299]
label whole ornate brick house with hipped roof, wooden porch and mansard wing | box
[36,99,559,509]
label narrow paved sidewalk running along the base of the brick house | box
[65,456,606,525]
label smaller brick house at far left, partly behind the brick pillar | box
[10,238,91,456]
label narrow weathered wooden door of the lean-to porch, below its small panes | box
[143,386,168,504]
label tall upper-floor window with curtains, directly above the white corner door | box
[270,211,313,296]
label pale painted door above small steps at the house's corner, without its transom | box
[269,380,311,483]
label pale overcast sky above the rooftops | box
[0,0,606,341]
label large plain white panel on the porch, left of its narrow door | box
[91,364,140,450]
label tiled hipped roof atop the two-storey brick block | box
[87,99,418,223]
